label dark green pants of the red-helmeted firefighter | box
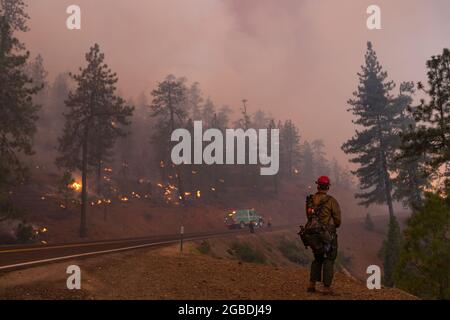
[310,236,338,287]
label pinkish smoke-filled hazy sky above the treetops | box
[22,0,450,162]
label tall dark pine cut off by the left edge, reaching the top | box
[0,0,41,189]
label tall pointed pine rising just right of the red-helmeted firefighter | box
[342,42,398,216]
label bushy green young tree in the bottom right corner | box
[395,193,450,300]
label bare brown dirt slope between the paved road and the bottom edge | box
[0,232,415,300]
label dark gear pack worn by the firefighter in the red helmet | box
[298,195,334,253]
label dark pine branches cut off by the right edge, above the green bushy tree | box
[403,49,450,191]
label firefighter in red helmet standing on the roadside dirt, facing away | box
[307,176,341,294]
